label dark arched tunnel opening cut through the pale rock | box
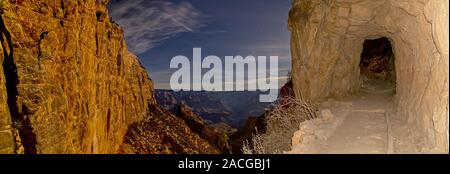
[359,37,396,86]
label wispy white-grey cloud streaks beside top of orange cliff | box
[110,0,204,54]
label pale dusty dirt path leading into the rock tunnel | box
[287,81,416,154]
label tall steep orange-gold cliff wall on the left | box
[0,0,220,153]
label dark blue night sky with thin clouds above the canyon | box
[109,0,291,89]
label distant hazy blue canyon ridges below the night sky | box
[155,89,272,129]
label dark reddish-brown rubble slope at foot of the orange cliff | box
[120,106,227,154]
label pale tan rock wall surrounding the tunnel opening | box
[289,0,449,152]
